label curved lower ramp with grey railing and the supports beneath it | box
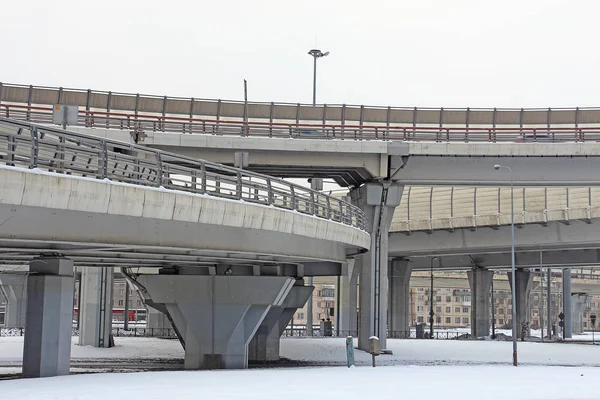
[0,118,371,377]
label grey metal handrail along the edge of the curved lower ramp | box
[0,117,367,231]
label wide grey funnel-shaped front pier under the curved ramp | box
[138,274,295,369]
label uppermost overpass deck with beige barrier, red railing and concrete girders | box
[5,83,600,187]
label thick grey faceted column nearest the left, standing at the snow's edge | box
[23,257,74,378]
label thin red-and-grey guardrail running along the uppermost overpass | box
[0,104,600,143]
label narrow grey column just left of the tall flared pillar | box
[339,259,360,336]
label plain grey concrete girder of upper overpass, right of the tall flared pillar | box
[390,152,600,187]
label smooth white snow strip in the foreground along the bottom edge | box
[0,366,600,400]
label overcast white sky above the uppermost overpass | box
[0,0,600,107]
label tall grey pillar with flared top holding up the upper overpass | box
[350,181,404,350]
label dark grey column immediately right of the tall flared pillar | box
[388,259,412,339]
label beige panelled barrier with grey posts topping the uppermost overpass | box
[0,82,600,127]
